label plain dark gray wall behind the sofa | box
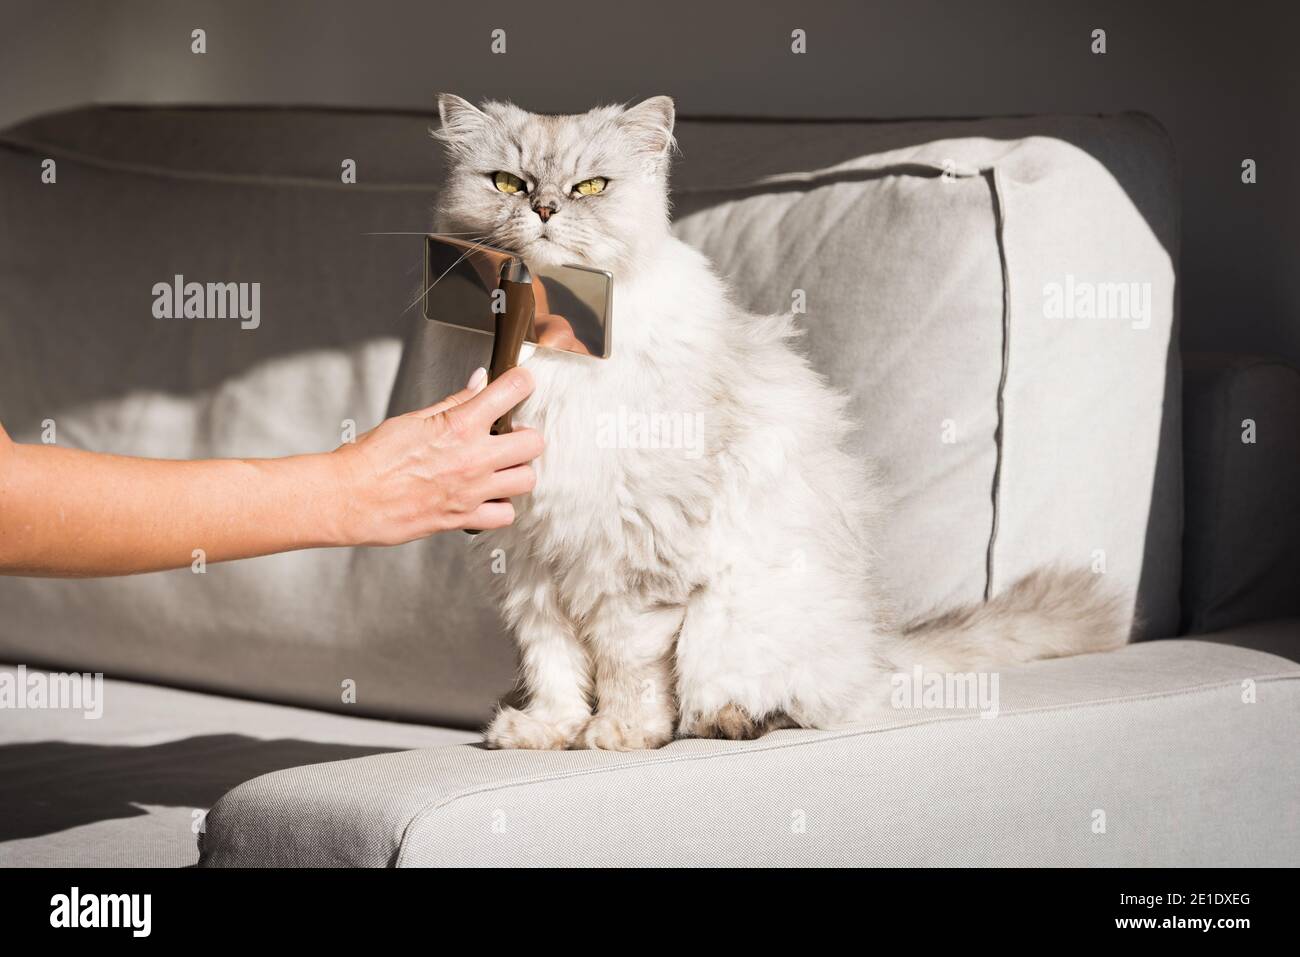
[0,0,1300,363]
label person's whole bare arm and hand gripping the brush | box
[0,368,542,577]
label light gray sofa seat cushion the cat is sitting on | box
[202,634,1300,866]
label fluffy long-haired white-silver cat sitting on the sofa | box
[434,94,1131,750]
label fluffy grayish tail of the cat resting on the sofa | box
[889,567,1132,672]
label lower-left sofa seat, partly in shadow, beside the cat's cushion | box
[0,666,477,867]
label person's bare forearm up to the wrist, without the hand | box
[0,439,345,576]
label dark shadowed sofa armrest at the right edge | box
[1182,352,1300,633]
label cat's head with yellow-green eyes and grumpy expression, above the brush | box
[436,94,673,273]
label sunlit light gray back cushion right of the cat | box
[675,116,1182,636]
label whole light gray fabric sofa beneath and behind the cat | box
[0,107,1300,867]
